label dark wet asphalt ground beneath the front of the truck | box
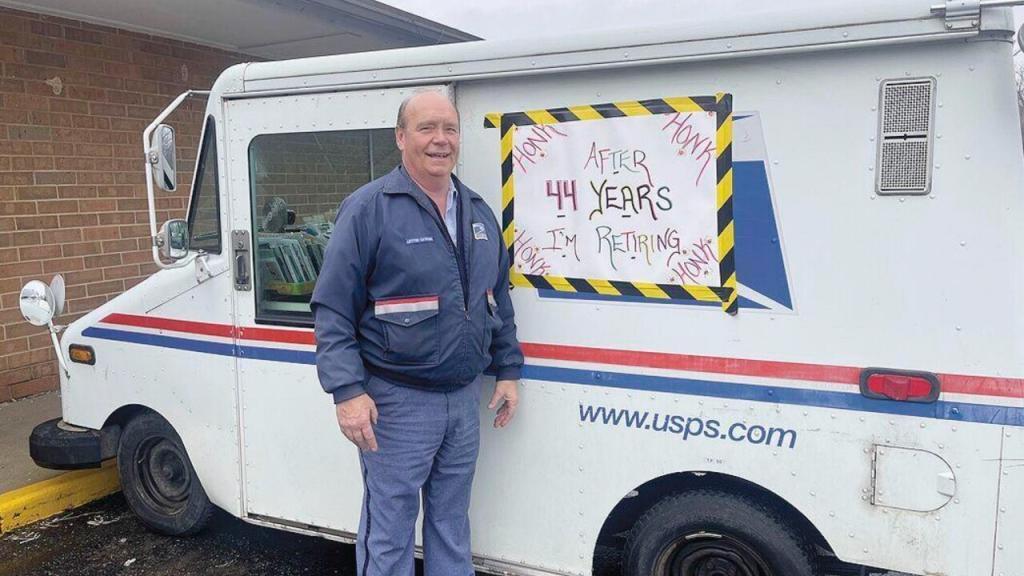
[0,493,617,576]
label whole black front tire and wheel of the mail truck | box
[118,412,213,536]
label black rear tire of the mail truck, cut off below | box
[623,490,814,576]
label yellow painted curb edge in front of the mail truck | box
[0,459,121,534]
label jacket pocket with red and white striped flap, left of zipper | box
[374,296,440,365]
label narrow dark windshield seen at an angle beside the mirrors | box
[188,116,220,254]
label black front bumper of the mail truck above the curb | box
[29,418,121,470]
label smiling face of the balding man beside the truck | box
[395,92,459,178]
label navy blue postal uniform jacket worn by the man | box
[310,166,522,403]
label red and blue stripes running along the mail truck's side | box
[82,314,1024,426]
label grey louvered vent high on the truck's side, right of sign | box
[876,78,935,195]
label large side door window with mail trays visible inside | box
[249,128,401,325]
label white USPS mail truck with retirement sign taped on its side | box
[16,0,1024,576]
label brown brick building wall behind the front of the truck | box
[0,7,254,402]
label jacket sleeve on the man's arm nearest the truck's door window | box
[309,197,377,404]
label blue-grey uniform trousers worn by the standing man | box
[355,377,480,576]
